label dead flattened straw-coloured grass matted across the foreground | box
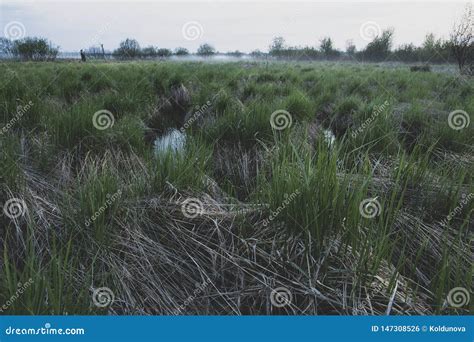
[2,153,467,315]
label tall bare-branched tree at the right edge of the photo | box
[450,4,474,73]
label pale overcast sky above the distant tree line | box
[0,0,473,52]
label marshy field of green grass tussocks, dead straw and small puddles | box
[0,61,474,315]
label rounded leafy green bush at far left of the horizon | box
[12,37,59,61]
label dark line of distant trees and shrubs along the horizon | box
[0,6,474,74]
